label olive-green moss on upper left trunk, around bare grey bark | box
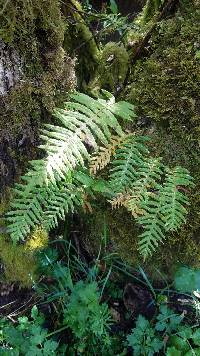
[0,0,76,127]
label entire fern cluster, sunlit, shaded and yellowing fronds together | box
[7,92,193,258]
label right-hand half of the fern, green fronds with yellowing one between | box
[104,136,194,259]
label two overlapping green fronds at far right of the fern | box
[137,167,194,259]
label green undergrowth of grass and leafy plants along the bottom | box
[0,241,200,356]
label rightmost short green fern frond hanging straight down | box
[162,167,194,231]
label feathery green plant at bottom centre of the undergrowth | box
[64,281,111,354]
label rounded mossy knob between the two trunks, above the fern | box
[99,42,129,92]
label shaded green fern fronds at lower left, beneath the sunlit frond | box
[7,180,82,242]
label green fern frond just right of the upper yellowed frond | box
[110,136,149,193]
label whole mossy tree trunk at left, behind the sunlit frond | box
[0,0,97,198]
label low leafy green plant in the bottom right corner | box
[127,305,200,356]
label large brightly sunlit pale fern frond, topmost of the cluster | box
[41,93,130,181]
